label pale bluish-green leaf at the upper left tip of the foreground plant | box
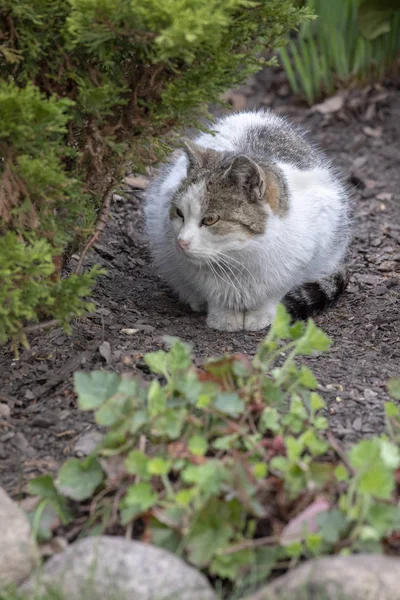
[74,371,121,410]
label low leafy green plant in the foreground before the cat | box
[30,306,400,582]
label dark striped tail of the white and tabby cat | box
[282,267,349,320]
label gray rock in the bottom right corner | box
[245,554,400,600]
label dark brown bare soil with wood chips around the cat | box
[0,71,400,495]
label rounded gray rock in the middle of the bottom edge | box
[22,536,216,600]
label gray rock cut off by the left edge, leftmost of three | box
[0,487,39,587]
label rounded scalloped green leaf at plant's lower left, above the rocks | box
[55,457,104,501]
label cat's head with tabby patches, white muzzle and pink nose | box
[170,141,286,261]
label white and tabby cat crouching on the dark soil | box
[145,111,350,331]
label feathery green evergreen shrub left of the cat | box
[0,0,308,342]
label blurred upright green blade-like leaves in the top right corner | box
[280,0,400,104]
